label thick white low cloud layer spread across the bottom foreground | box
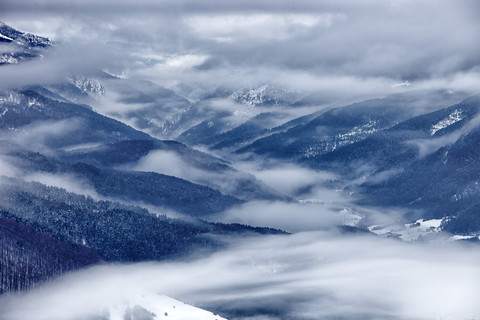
[0,232,480,320]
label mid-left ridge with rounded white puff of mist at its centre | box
[58,140,279,200]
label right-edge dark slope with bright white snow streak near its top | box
[312,97,479,172]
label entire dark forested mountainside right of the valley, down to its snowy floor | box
[266,96,480,236]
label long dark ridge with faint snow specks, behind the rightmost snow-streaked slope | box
[236,92,461,163]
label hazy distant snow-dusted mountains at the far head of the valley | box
[78,78,308,154]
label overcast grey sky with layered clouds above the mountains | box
[0,0,480,94]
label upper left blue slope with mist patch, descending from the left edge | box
[0,90,152,149]
